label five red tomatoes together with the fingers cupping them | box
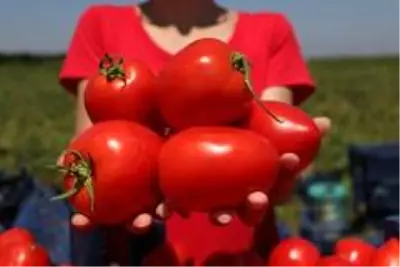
[56,39,330,232]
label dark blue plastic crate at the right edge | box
[348,142,400,222]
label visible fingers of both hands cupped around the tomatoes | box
[71,117,331,233]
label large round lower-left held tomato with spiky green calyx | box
[56,121,162,225]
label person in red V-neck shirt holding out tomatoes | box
[60,0,330,266]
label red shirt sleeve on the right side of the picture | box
[266,15,315,105]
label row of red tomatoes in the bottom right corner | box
[268,237,400,267]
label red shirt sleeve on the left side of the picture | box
[59,7,104,94]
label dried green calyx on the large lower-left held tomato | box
[51,150,94,211]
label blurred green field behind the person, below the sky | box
[0,56,400,184]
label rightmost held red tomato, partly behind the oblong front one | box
[245,101,321,172]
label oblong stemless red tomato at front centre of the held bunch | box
[159,127,279,212]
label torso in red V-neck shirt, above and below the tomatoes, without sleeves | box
[94,6,282,267]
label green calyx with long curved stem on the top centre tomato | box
[231,52,283,123]
